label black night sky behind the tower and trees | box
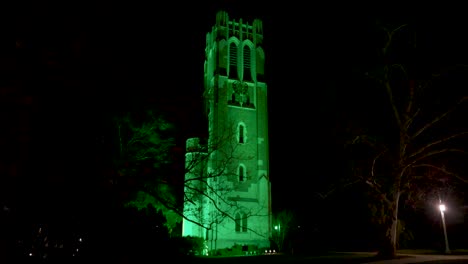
[9,1,468,251]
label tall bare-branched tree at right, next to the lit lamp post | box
[322,21,468,258]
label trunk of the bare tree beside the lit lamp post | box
[378,192,400,259]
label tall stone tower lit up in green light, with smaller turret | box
[182,11,271,253]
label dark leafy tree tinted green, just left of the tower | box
[109,110,181,231]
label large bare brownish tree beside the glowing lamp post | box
[330,25,468,258]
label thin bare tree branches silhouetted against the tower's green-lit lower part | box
[182,121,268,245]
